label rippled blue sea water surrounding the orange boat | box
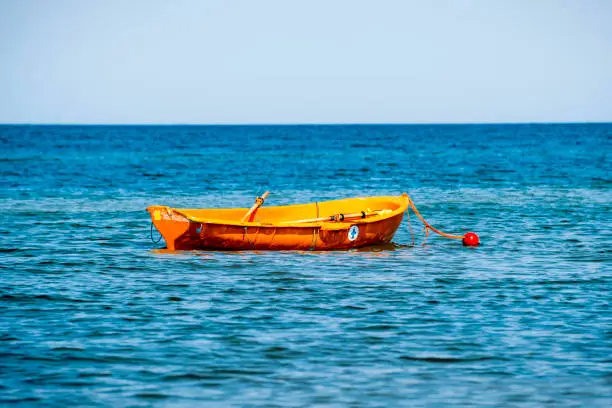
[0,124,612,407]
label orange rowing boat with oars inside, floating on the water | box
[147,192,410,250]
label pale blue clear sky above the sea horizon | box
[0,0,612,124]
